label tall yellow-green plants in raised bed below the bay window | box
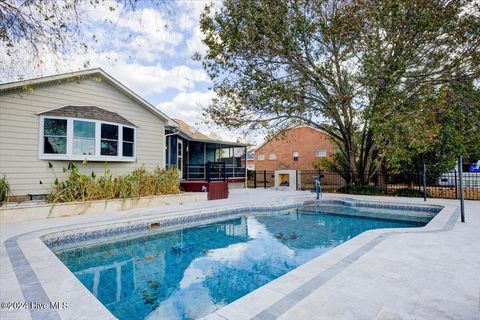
[47,163,180,203]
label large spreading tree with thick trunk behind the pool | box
[201,0,480,183]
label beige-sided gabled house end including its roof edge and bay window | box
[0,69,178,198]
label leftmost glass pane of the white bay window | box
[43,119,67,154]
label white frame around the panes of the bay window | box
[38,115,137,162]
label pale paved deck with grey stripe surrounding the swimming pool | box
[0,189,480,320]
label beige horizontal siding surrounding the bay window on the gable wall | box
[0,79,165,195]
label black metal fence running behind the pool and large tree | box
[247,170,480,200]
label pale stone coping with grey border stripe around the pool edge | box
[4,195,458,320]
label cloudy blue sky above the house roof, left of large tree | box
[0,0,262,144]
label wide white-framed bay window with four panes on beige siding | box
[39,116,135,161]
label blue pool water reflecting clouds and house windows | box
[56,205,429,319]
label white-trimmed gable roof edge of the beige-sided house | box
[0,68,177,127]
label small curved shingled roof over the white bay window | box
[38,106,135,126]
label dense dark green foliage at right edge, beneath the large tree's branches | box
[378,81,480,175]
